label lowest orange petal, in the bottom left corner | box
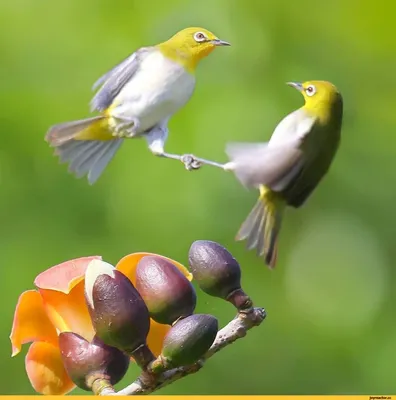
[25,342,75,395]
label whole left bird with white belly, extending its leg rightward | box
[46,28,229,184]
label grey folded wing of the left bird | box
[91,47,153,112]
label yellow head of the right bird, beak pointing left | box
[287,81,342,119]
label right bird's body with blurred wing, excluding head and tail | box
[227,109,340,207]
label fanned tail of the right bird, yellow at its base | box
[236,186,285,269]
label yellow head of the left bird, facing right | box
[158,27,230,72]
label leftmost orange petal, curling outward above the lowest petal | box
[10,290,58,356]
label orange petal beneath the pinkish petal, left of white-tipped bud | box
[39,280,95,340]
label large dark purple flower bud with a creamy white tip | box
[85,260,150,355]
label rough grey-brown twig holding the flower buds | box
[100,307,266,396]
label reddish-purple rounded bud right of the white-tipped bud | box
[136,256,197,325]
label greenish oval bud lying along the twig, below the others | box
[152,314,218,371]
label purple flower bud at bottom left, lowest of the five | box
[59,332,130,391]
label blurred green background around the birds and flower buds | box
[0,0,396,394]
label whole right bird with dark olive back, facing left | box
[222,81,343,268]
